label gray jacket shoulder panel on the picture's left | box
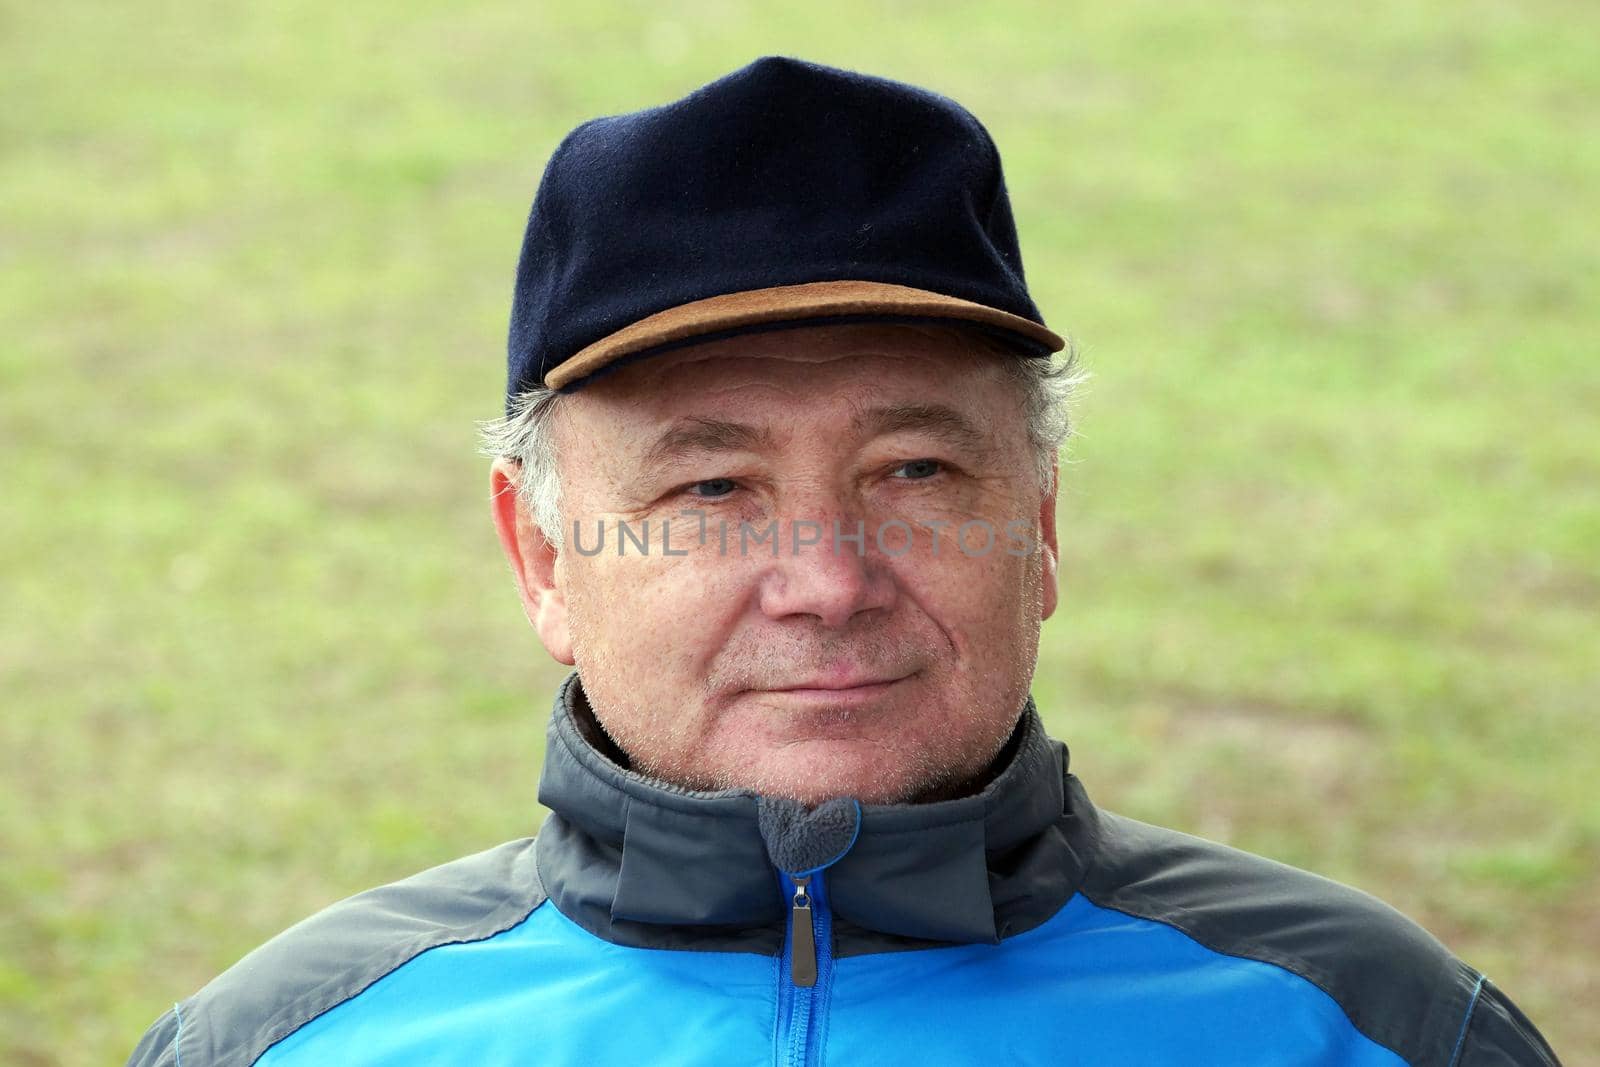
[130,838,546,1067]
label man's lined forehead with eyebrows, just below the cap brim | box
[537,323,1029,499]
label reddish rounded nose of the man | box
[760,512,896,629]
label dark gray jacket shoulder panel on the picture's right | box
[1082,809,1544,1067]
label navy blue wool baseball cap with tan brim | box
[506,56,1064,405]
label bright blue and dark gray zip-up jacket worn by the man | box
[130,673,1557,1067]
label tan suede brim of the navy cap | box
[544,282,1066,389]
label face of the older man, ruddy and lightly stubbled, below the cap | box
[494,325,1056,803]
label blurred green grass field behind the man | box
[0,0,1600,1067]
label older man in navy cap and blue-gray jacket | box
[133,58,1555,1067]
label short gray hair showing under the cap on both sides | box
[478,331,1090,549]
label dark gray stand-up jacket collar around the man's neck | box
[538,672,1098,955]
